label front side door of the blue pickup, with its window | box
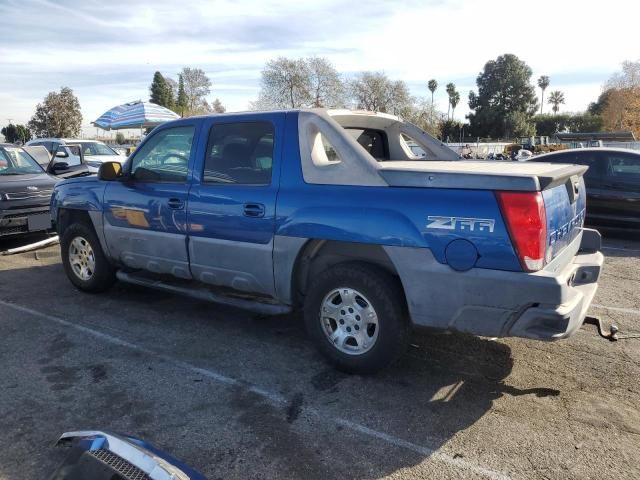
[104,123,197,278]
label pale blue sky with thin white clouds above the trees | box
[0,0,640,135]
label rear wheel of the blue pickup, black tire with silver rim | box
[304,263,409,373]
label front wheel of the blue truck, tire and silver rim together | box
[60,223,116,292]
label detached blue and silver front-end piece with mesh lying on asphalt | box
[49,430,206,480]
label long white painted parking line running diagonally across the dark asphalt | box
[0,300,511,480]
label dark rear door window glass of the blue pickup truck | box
[202,122,274,185]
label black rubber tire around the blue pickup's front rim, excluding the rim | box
[60,223,116,293]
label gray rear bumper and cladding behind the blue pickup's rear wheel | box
[385,229,604,340]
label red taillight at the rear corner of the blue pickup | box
[496,192,547,272]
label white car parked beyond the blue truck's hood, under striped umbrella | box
[26,138,126,173]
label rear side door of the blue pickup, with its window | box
[188,114,285,295]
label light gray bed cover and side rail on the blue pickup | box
[379,160,587,191]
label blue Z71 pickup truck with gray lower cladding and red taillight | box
[51,110,603,372]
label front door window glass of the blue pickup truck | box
[131,126,195,182]
